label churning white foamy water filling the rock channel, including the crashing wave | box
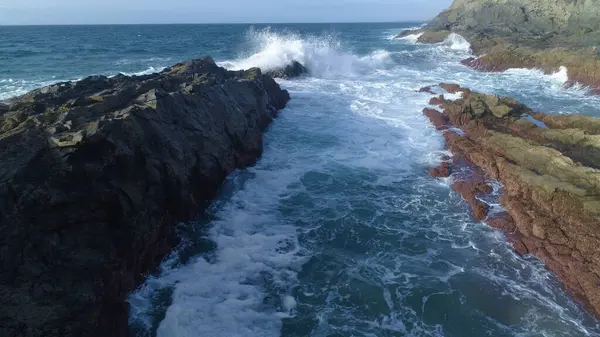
[130,30,598,337]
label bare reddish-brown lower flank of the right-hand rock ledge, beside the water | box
[424,85,600,316]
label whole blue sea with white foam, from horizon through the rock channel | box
[0,23,600,337]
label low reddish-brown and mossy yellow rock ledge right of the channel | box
[424,85,600,315]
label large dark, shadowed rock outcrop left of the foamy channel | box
[0,57,290,337]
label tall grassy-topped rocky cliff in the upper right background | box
[404,0,600,93]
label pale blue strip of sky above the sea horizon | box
[0,0,452,25]
